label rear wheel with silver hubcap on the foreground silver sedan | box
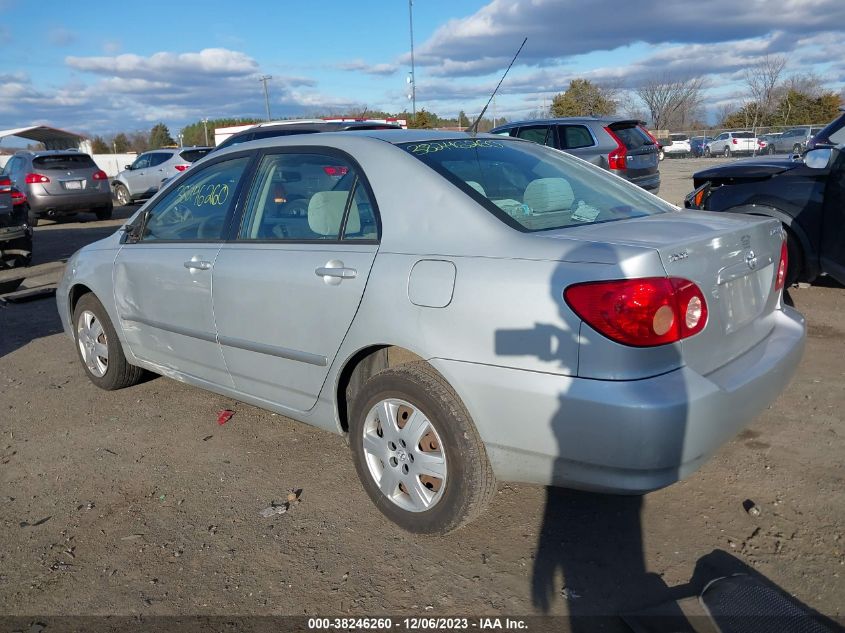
[349,362,496,534]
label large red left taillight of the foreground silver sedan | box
[563,277,707,347]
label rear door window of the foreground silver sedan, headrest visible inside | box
[234,153,378,241]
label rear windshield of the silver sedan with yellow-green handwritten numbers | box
[399,139,674,231]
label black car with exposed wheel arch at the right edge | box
[685,145,845,284]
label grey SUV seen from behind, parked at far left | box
[3,150,112,226]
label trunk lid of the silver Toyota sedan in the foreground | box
[549,211,783,374]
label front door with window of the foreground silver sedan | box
[113,155,250,387]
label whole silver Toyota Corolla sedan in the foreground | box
[56,128,805,532]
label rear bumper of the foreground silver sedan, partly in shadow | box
[432,308,805,494]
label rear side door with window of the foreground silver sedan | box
[213,148,379,411]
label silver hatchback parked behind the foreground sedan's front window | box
[112,147,212,206]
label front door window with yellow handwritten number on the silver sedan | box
[141,156,250,242]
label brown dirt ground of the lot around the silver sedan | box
[0,160,845,617]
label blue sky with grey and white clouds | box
[0,0,845,134]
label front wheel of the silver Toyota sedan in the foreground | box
[73,293,144,391]
